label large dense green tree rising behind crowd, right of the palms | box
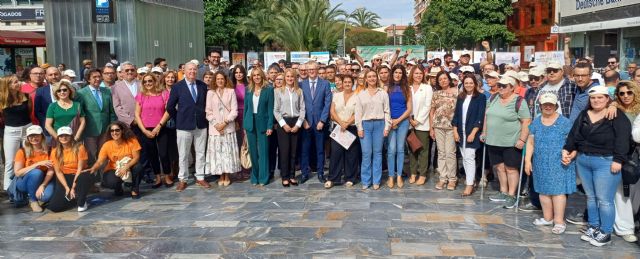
[420,0,515,49]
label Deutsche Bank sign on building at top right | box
[556,0,638,17]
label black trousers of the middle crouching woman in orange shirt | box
[47,173,93,212]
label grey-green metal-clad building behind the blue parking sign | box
[44,0,205,75]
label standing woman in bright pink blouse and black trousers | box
[135,75,173,189]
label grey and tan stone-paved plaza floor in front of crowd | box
[0,173,640,258]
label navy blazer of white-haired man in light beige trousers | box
[167,79,209,130]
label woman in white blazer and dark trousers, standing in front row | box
[409,65,433,185]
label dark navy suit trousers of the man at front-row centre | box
[300,125,327,179]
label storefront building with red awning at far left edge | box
[0,0,46,76]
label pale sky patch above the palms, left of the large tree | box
[330,0,414,26]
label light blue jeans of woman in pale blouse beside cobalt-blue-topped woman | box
[360,120,384,186]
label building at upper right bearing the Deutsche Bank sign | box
[558,0,640,68]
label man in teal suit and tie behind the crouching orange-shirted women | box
[76,68,118,165]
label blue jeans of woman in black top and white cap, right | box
[576,153,622,234]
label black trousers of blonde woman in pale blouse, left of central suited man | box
[276,118,302,180]
